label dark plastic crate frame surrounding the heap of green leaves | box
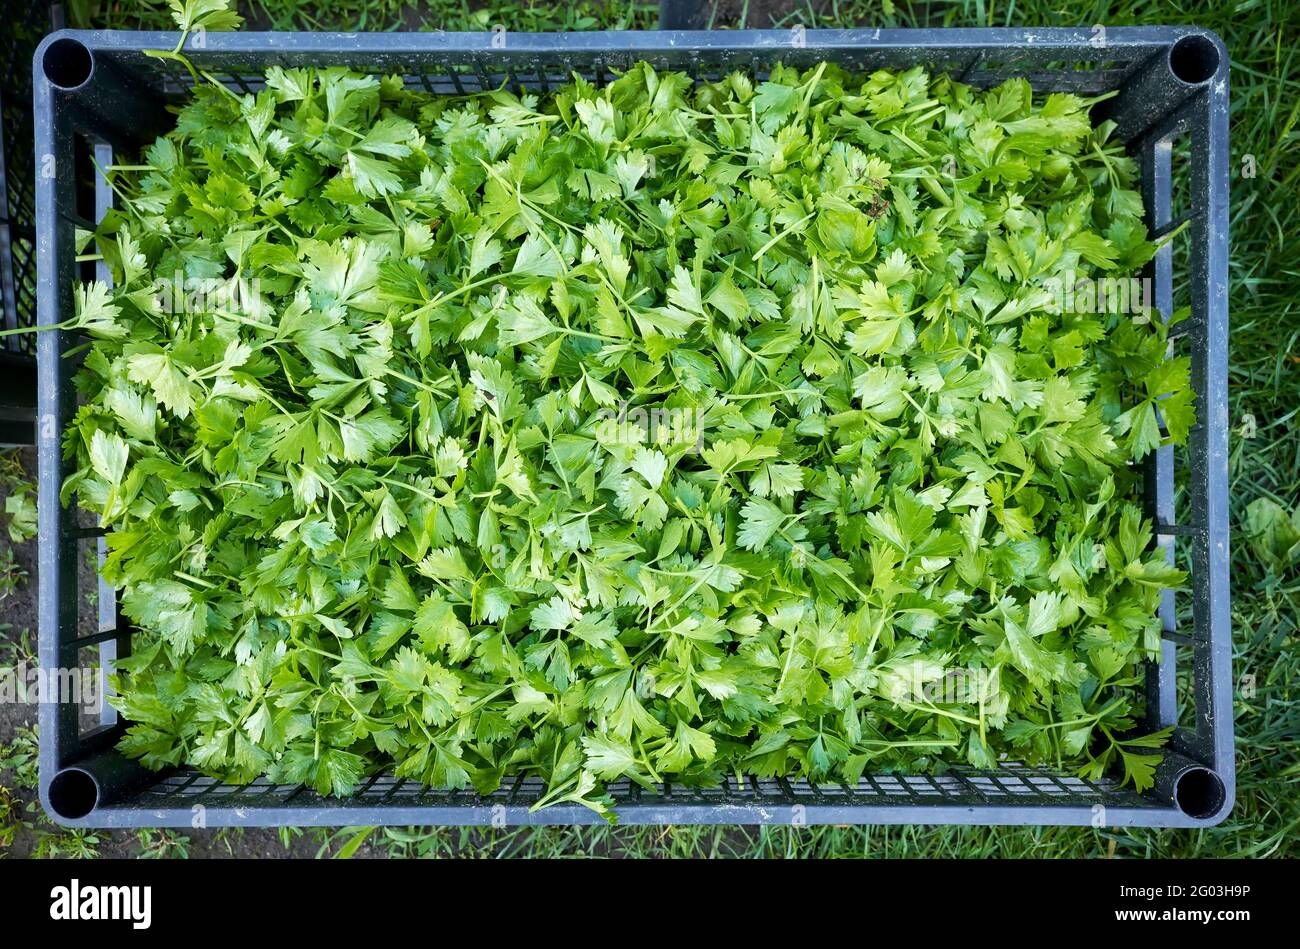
[35,20,1235,827]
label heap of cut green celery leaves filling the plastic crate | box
[65,51,1193,809]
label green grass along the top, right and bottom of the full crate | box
[0,0,1300,858]
